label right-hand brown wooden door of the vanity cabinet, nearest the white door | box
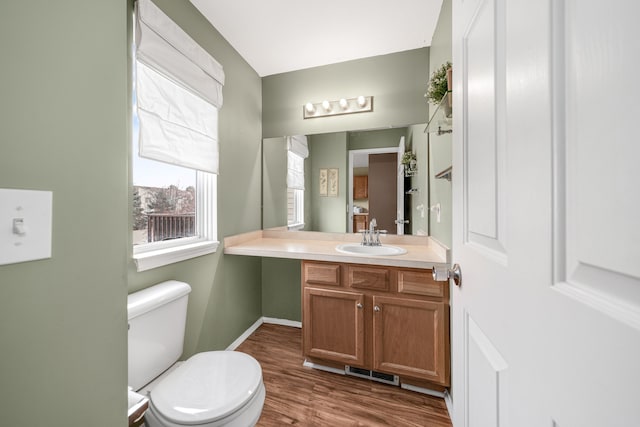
[373,296,449,386]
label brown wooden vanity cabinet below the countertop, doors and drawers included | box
[302,261,450,389]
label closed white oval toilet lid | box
[150,351,262,425]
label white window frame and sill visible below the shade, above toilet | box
[133,171,220,271]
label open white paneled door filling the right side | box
[451,0,640,427]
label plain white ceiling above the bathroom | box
[190,0,442,77]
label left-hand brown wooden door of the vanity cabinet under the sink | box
[302,287,364,365]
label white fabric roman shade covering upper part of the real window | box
[136,0,224,173]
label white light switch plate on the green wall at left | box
[0,188,53,265]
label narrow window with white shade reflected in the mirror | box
[287,136,309,229]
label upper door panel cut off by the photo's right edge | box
[554,1,640,327]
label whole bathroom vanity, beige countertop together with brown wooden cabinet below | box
[225,230,450,391]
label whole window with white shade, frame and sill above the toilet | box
[132,0,224,271]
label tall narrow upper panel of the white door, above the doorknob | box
[461,0,506,262]
